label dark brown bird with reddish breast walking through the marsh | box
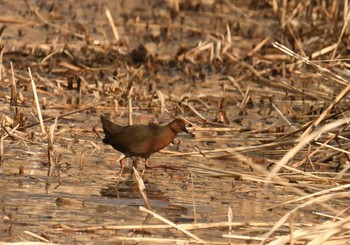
[101,115,189,173]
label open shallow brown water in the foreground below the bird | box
[0,136,310,243]
